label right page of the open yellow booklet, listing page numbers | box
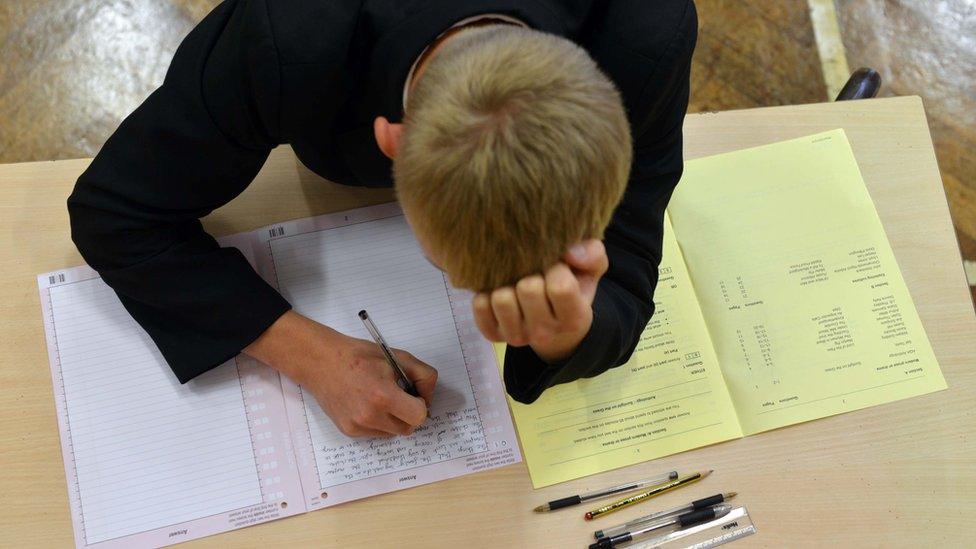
[669,130,946,434]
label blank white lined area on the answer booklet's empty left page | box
[49,278,262,545]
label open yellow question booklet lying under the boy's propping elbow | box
[511,130,946,488]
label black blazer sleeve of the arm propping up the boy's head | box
[504,1,698,404]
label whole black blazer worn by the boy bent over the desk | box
[68,0,697,402]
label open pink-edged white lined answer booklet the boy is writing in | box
[38,204,521,547]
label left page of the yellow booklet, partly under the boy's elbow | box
[496,216,742,488]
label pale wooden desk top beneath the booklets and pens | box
[0,97,976,548]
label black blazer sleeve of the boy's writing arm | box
[68,0,289,383]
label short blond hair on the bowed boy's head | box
[394,25,632,291]
